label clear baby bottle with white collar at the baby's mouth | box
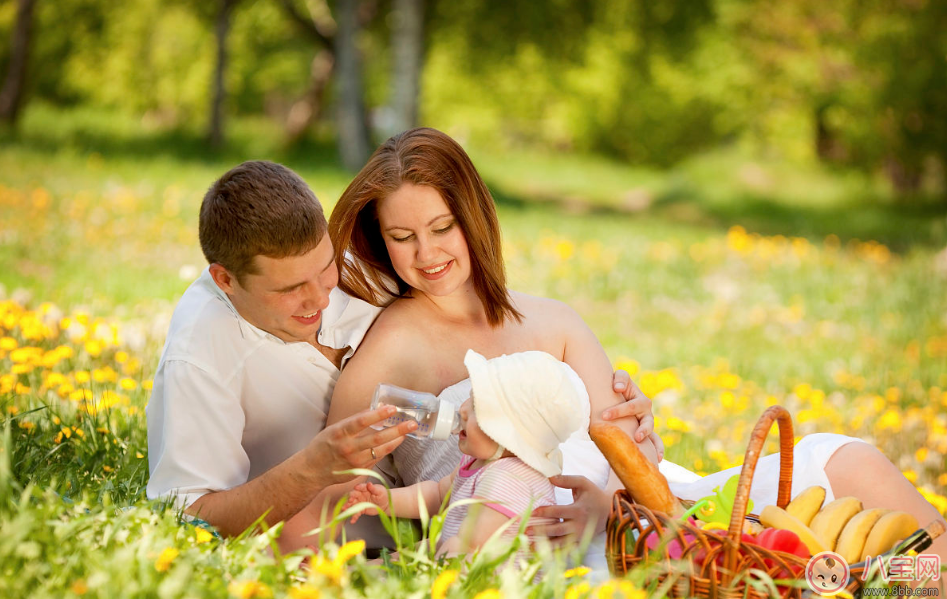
[372,383,461,440]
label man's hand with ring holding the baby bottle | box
[305,405,418,486]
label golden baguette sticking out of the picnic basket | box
[589,422,684,517]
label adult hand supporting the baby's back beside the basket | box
[527,475,611,547]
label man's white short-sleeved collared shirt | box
[146,269,382,508]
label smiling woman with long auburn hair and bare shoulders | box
[329,128,947,554]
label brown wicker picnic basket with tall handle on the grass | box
[606,406,862,599]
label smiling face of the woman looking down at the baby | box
[378,183,472,297]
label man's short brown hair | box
[200,160,326,283]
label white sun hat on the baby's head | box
[464,349,589,476]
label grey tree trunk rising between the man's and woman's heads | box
[335,0,369,171]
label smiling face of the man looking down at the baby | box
[214,234,339,345]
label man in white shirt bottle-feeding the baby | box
[147,161,661,548]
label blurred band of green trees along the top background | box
[0,0,947,195]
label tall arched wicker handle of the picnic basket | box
[727,406,793,571]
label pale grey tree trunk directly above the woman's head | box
[390,0,424,134]
